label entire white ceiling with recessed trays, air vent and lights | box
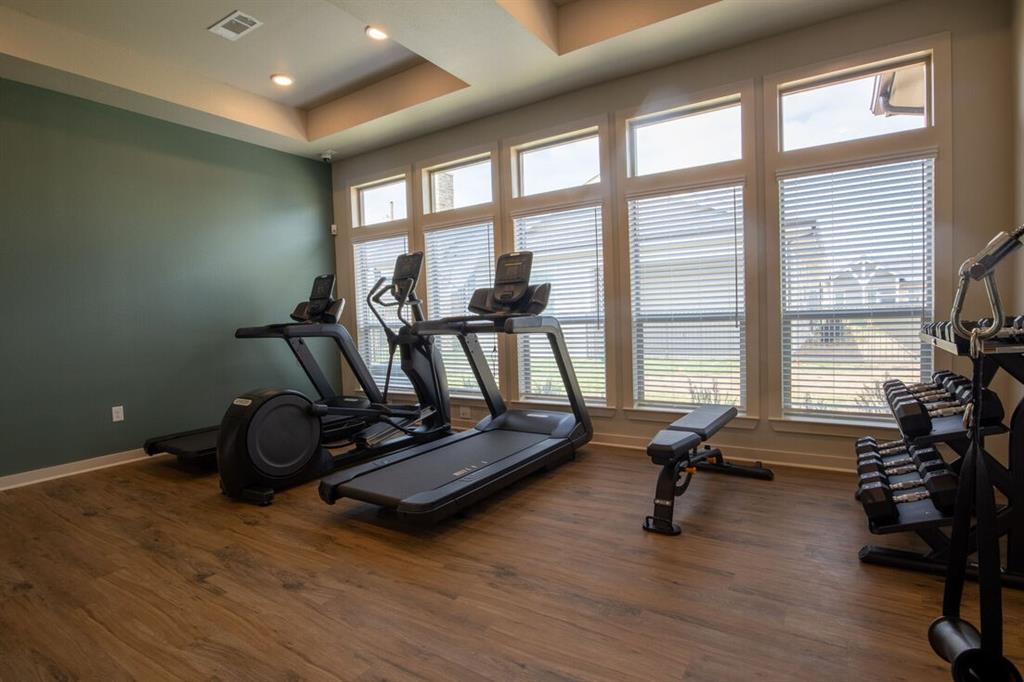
[0,0,890,158]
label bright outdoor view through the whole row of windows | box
[355,49,935,417]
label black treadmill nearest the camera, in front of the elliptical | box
[319,251,594,523]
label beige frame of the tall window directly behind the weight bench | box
[608,80,763,430]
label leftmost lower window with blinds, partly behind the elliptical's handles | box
[352,236,412,390]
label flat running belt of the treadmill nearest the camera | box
[341,429,551,501]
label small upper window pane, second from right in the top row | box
[629,102,742,175]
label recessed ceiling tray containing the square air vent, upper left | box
[0,0,423,109]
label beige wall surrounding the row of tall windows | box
[334,0,1024,468]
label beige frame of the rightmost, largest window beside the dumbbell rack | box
[762,34,955,435]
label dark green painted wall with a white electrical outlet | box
[0,79,339,475]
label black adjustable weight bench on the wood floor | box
[643,406,775,536]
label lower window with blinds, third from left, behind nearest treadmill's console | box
[515,206,606,402]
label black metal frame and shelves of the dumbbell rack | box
[860,334,1024,589]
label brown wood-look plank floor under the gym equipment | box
[0,447,1024,682]
